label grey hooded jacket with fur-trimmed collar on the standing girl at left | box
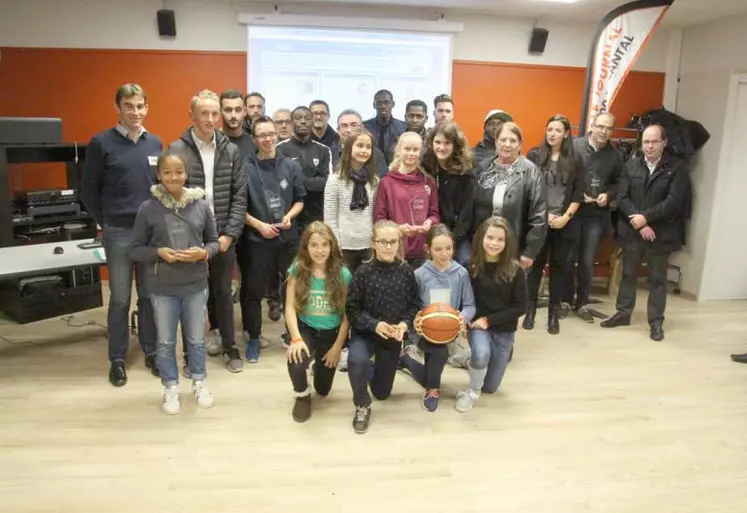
[130,184,218,296]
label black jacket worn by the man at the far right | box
[618,152,690,253]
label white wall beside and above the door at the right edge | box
[673,16,747,300]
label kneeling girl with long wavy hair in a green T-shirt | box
[285,221,352,422]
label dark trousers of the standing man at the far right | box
[616,241,671,323]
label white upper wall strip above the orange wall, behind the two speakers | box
[0,0,668,71]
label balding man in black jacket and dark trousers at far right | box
[601,125,690,342]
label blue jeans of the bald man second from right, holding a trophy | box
[563,217,606,308]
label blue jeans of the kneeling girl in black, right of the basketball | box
[467,330,516,394]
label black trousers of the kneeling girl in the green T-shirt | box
[288,320,340,396]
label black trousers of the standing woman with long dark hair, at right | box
[527,230,573,305]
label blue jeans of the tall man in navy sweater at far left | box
[103,226,156,362]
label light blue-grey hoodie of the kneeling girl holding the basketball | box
[415,260,475,323]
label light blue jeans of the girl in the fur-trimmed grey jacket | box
[152,288,208,387]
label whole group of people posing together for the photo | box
[81,84,688,433]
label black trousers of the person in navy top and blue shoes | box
[238,239,298,339]
